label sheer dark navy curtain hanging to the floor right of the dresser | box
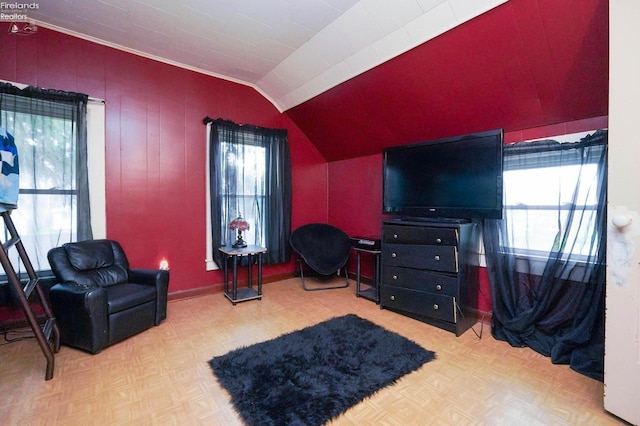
[482,131,607,381]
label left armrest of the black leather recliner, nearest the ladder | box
[49,282,109,354]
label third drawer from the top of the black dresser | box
[382,265,458,297]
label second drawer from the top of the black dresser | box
[382,244,458,274]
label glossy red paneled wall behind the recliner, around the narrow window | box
[0,23,328,293]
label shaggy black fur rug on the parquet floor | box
[209,315,435,426]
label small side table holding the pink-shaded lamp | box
[219,245,267,306]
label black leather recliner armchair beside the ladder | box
[47,240,169,354]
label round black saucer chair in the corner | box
[289,223,351,291]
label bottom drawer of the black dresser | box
[380,285,457,323]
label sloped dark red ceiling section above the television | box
[286,0,609,161]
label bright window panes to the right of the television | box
[504,130,603,260]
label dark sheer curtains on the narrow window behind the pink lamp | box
[204,117,291,265]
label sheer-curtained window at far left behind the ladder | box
[0,83,91,276]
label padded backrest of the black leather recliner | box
[47,240,129,287]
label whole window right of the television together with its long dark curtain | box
[481,130,608,378]
